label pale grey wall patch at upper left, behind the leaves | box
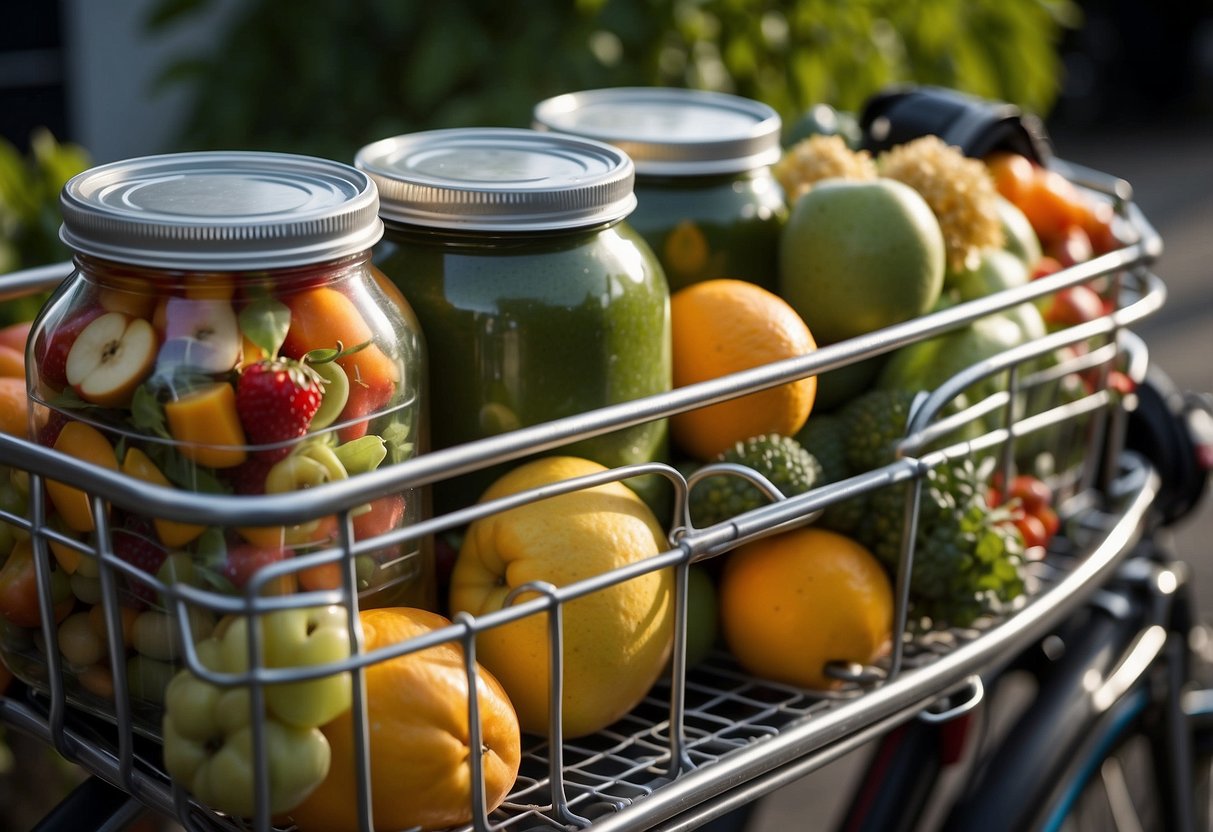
[61,0,239,164]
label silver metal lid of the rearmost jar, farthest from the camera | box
[533,87,782,176]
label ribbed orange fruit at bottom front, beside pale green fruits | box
[291,606,522,832]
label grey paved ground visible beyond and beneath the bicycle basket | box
[751,114,1213,832]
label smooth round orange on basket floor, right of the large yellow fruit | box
[719,526,893,690]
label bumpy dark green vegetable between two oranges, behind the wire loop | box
[690,433,822,528]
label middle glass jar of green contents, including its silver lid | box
[354,129,671,511]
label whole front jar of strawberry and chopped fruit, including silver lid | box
[8,153,437,735]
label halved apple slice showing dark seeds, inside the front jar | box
[64,312,158,408]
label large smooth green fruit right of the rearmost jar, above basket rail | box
[779,178,945,344]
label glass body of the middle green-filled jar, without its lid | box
[376,222,671,511]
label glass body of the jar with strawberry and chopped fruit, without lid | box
[7,251,437,736]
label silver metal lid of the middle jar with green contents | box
[354,127,636,232]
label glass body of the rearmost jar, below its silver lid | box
[628,167,787,292]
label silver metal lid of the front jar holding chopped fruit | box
[59,152,383,270]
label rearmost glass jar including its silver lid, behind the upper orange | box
[533,87,787,292]
